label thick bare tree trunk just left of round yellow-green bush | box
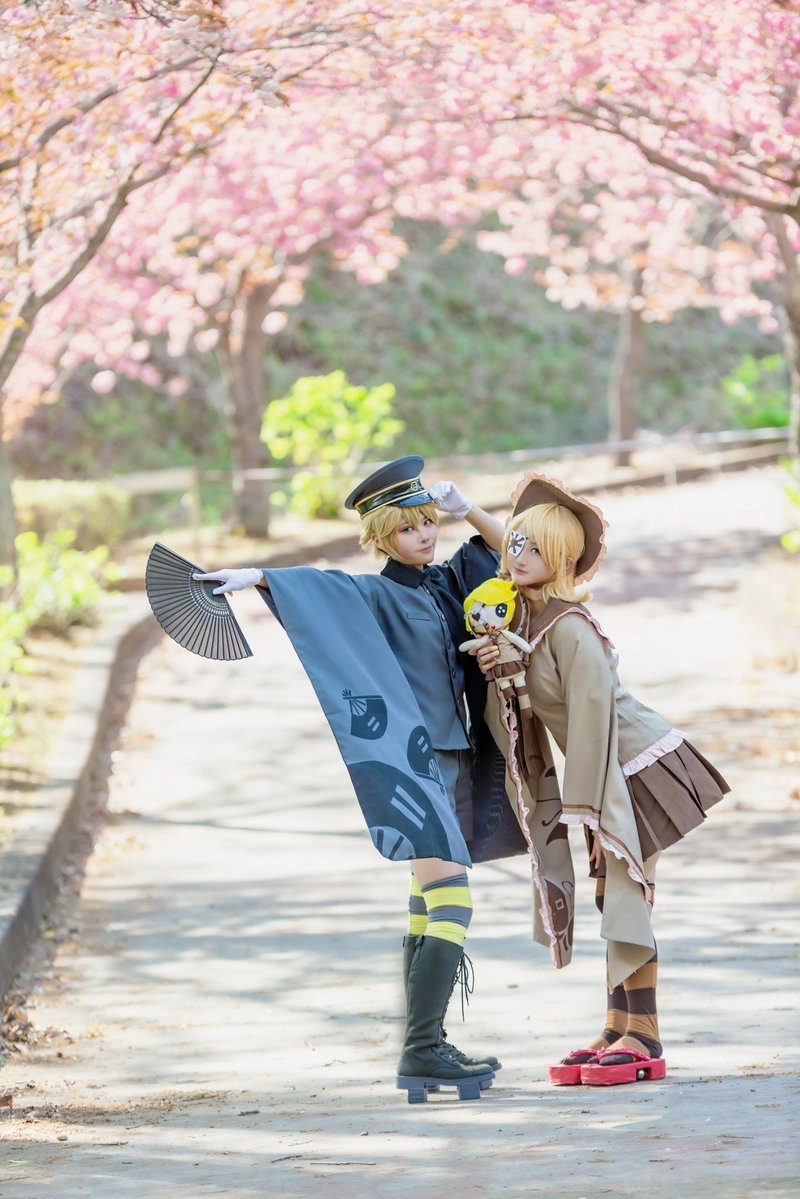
[223,283,273,537]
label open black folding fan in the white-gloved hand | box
[144,542,253,662]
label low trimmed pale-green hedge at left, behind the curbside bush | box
[13,478,131,549]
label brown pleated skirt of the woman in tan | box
[626,741,730,858]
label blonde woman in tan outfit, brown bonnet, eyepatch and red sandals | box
[479,475,728,1085]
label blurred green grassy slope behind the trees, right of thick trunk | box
[266,229,777,453]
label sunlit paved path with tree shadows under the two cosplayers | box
[0,470,800,1199]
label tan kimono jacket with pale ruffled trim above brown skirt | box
[489,600,682,987]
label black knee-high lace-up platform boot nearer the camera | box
[397,936,494,1103]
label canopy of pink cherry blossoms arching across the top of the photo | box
[0,0,800,561]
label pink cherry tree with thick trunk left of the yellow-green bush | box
[8,96,500,536]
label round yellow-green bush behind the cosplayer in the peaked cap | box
[261,370,404,517]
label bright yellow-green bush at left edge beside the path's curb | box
[0,530,118,748]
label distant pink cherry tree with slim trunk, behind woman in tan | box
[479,131,776,463]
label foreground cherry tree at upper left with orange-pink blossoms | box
[0,0,419,560]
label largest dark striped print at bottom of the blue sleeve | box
[348,761,450,862]
